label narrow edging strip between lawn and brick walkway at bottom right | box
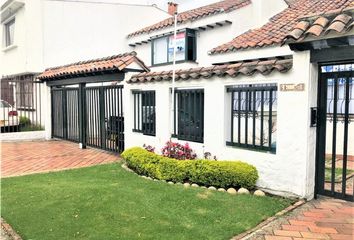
[230,199,306,240]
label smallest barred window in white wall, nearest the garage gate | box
[133,91,156,136]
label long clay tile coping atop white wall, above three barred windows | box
[127,58,292,83]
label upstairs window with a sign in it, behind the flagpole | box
[152,29,196,65]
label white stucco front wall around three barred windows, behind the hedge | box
[124,52,317,198]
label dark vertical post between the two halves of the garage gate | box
[78,83,86,149]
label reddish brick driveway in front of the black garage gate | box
[1,141,119,177]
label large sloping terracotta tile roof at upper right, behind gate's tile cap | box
[210,0,354,54]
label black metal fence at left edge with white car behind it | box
[0,74,44,133]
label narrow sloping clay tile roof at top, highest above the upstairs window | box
[128,0,251,37]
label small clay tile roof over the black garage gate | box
[37,52,150,80]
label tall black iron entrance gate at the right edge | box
[316,63,354,201]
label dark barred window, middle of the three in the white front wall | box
[173,89,204,142]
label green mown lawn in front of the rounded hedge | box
[1,164,291,240]
